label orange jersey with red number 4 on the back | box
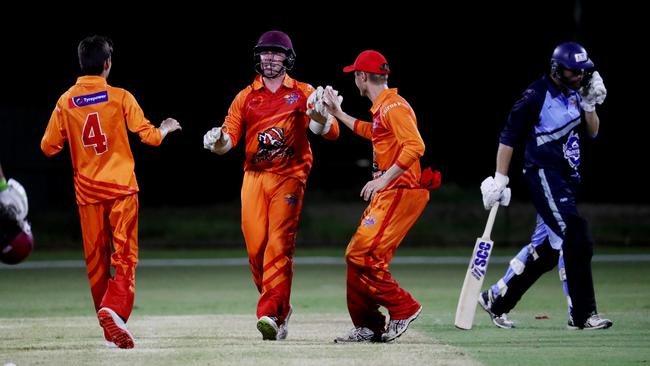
[41,76,162,205]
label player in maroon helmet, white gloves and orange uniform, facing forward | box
[203,31,339,340]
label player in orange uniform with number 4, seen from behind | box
[41,36,180,348]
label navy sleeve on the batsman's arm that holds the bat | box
[499,84,545,147]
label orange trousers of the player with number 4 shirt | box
[79,194,138,322]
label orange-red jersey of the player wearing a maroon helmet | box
[223,75,339,183]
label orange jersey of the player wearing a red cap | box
[354,89,424,189]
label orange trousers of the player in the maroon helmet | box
[241,171,305,324]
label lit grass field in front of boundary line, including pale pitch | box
[0,252,650,366]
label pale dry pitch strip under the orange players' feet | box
[0,313,479,366]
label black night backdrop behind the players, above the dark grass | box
[0,1,650,217]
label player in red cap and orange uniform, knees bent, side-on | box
[323,50,429,342]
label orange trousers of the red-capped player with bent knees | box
[345,188,429,334]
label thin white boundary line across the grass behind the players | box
[0,254,650,270]
